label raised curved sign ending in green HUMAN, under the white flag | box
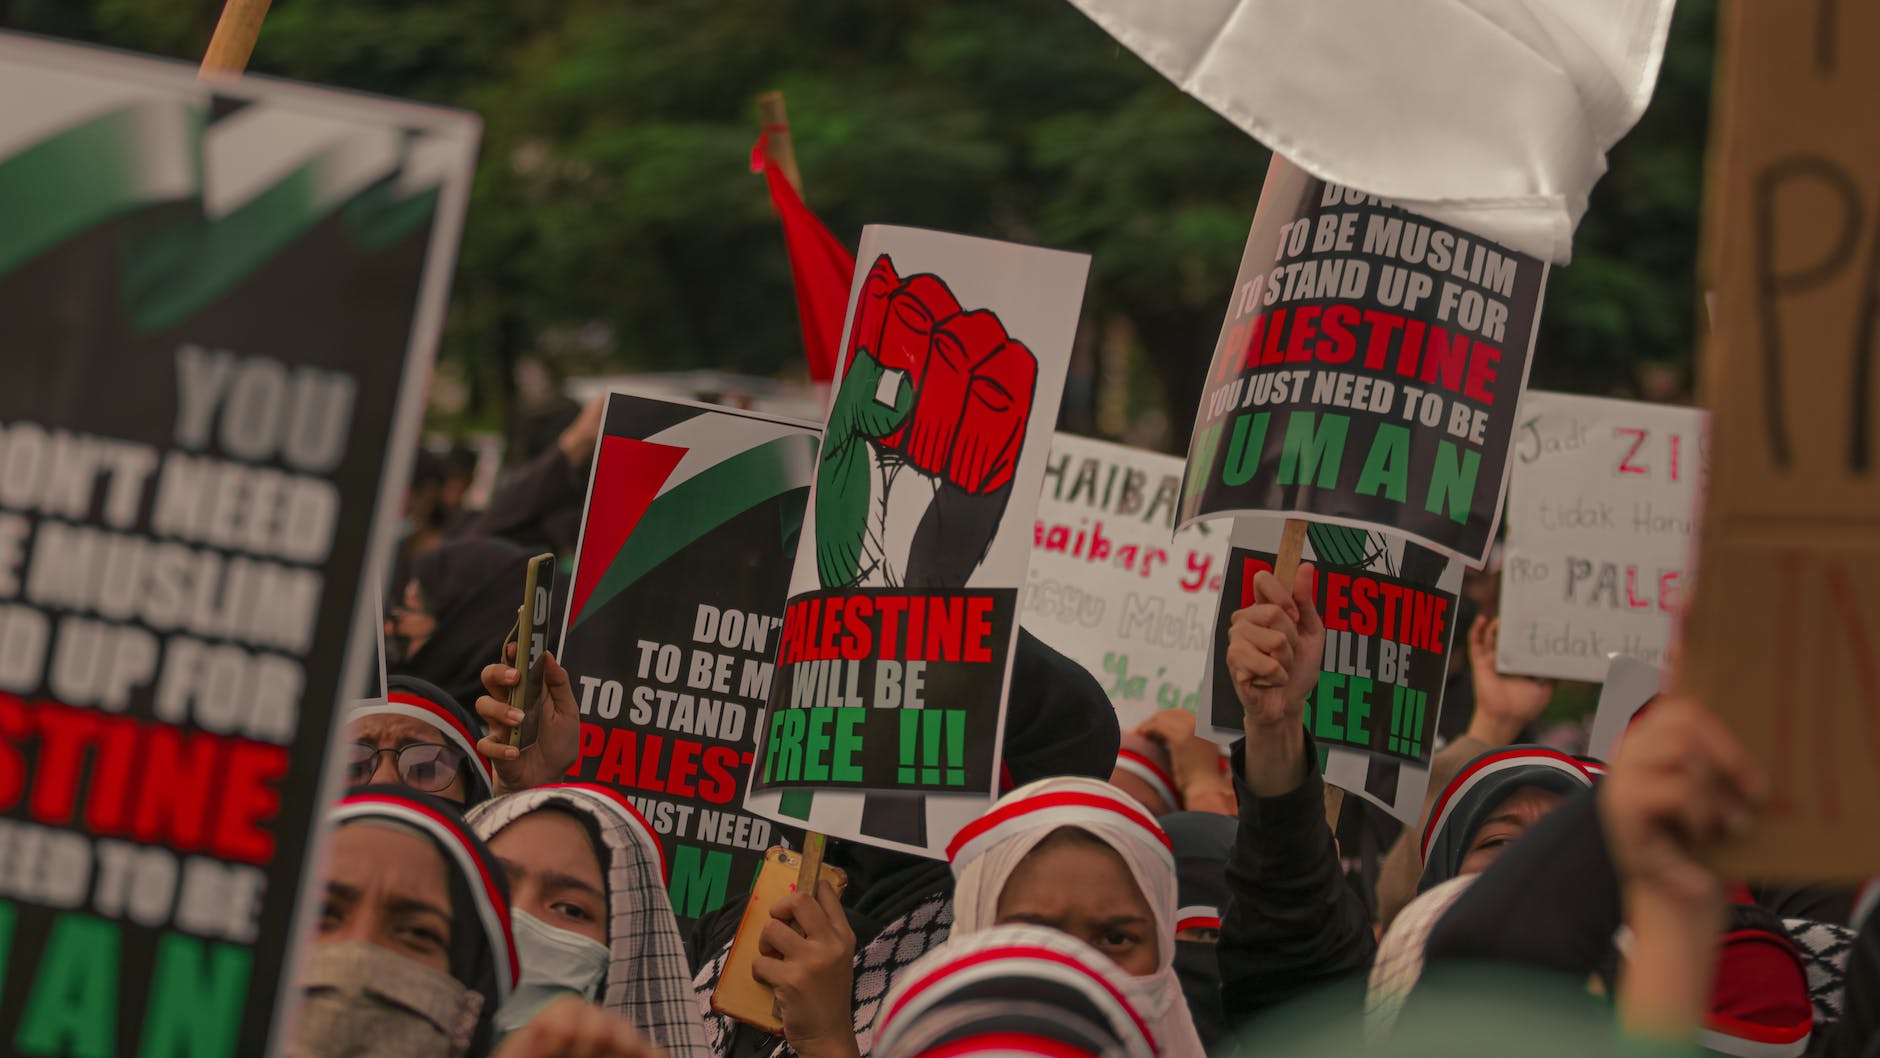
[1181,165,1547,566]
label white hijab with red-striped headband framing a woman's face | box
[948,776,1205,1058]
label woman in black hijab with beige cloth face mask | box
[286,786,517,1058]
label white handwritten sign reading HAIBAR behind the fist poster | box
[1019,434,1228,731]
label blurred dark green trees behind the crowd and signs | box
[0,0,1715,451]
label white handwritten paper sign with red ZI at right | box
[1495,393,1709,682]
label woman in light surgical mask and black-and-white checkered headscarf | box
[470,784,707,1058]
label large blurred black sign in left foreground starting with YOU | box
[0,36,478,1056]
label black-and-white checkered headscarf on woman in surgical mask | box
[470,784,709,1058]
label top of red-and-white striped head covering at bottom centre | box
[876,926,1160,1058]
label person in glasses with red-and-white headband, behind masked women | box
[346,677,493,806]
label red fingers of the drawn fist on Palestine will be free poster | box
[850,254,1038,492]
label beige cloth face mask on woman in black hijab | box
[286,940,483,1058]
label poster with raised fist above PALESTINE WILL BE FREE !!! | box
[746,227,1090,855]
